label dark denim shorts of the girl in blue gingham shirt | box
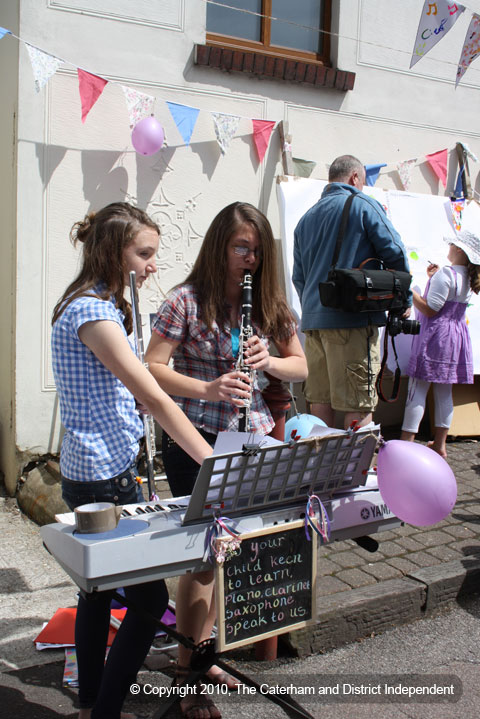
[62,464,145,510]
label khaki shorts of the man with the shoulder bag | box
[303,327,380,412]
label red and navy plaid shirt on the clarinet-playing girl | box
[153,285,274,434]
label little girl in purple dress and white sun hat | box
[401,230,480,458]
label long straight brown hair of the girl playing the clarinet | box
[182,202,294,339]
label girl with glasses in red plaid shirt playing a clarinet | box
[146,202,307,719]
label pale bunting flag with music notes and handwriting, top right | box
[410,0,465,68]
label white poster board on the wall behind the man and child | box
[277,177,480,374]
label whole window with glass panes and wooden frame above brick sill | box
[207,0,331,64]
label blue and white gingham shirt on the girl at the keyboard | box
[52,296,143,482]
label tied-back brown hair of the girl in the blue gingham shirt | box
[52,202,160,332]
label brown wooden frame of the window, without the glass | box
[206,0,332,67]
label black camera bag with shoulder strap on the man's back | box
[318,194,412,312]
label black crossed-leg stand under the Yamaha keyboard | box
[105,590,315,719]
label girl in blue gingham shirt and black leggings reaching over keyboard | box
[52,202,212,719]
